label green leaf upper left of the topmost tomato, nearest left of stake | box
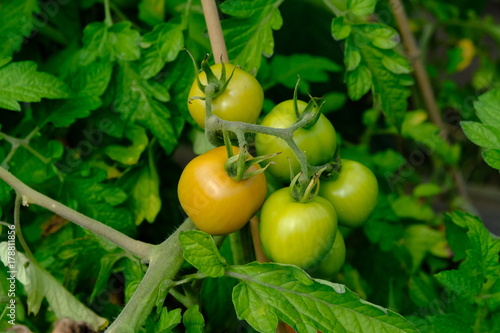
[141,19,186,79]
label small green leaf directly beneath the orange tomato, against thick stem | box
[179,231,227,277]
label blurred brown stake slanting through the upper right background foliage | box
[389,0,470,203]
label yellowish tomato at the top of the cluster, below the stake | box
[188,64,264,128]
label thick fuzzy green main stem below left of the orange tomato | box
[106,219,196,333]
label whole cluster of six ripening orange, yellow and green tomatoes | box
[178,64,378,279]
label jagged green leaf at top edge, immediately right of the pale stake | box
[220,0,283,73]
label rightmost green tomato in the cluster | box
[319,159,378,228]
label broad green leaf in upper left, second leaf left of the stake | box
[82,21,140,64]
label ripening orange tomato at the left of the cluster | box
[177,146,267,235]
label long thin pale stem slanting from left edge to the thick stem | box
[0,167,153,260]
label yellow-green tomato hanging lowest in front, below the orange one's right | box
[260,187,337,269]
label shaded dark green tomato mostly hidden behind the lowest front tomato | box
[308,230,345,280]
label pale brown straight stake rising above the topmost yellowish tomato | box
[201,0,229,63]
